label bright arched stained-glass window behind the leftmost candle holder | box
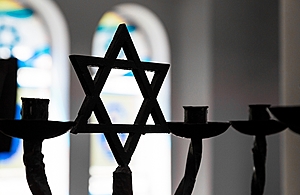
[0,0,69,195]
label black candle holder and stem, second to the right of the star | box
[230,104,287,195]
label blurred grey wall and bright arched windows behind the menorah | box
[0,0,300,195]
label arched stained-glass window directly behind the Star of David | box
[89,4,171,195]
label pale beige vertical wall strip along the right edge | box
[280,0,300,195]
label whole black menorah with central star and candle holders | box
[0,24,300,195]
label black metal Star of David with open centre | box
[70,24,170,166]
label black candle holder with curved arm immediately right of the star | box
[168,106,230,195]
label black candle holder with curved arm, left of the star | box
[0,98,74,195]
